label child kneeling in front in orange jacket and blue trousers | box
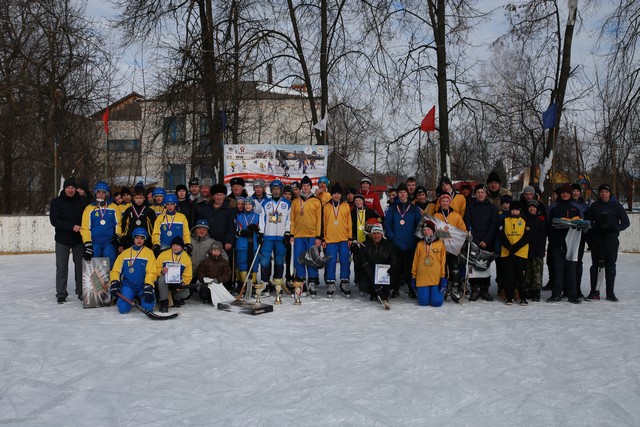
[411,220,447,307]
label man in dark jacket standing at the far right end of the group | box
[587,184,629,302]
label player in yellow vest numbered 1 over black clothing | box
[498,200,531,305]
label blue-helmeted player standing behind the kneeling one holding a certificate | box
[152,194,193,255]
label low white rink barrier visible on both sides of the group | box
[0,213,640,253]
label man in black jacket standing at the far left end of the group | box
[49,178,88,304]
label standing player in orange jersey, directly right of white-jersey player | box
[291,175,322,297]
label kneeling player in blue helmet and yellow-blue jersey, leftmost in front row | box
[109,228,156,314]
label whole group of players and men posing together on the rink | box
[50,172,629,313]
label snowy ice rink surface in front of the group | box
[0,254,640,426]
